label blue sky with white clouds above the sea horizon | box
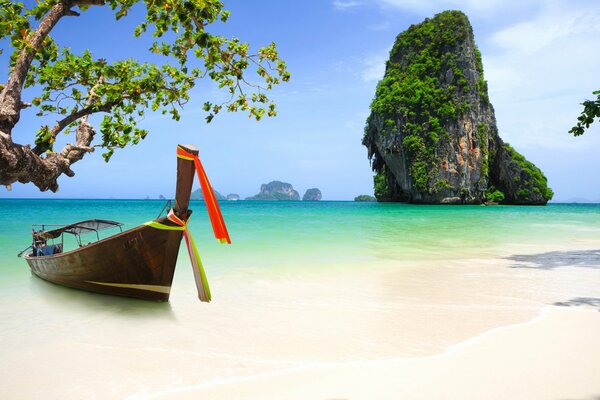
[0,0,600,202]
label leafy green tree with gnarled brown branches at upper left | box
[0,0,290,192]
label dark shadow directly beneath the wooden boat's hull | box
[31,274,175,319]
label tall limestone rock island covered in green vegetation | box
[363,11,553,205]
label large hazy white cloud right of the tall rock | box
[486,1,600,150]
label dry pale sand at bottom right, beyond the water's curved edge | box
[146,306,600,400]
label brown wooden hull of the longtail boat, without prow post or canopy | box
[24,218,183,301]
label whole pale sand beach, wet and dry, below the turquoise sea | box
[0,239,600,400]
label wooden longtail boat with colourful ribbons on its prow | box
[20,145,231,302]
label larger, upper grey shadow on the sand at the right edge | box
[507,250,600,270]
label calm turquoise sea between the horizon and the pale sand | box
[0,199,600,282]
